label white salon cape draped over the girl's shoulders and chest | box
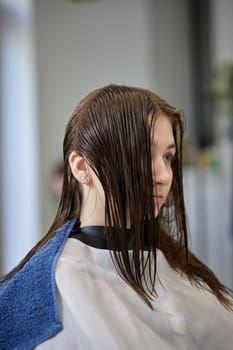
[36,238,233,350]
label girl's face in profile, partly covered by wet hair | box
[151,114,176,216]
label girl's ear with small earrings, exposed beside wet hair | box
[69,151,91,185]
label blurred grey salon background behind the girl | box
[0,0,233,288]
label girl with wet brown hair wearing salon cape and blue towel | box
[0,85,233,350]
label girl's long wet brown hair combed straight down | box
[1,85,232,308]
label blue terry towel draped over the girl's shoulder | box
[0,220,75,350]
